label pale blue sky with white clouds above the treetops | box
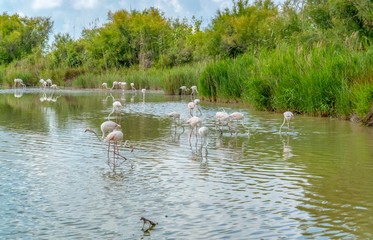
[0,0,232,39]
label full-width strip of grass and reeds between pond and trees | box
[0,44,373,125]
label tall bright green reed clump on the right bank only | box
[199,44,373,123]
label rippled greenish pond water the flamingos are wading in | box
[0,89,373,239]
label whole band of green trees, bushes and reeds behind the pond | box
[0,0,373,125]
